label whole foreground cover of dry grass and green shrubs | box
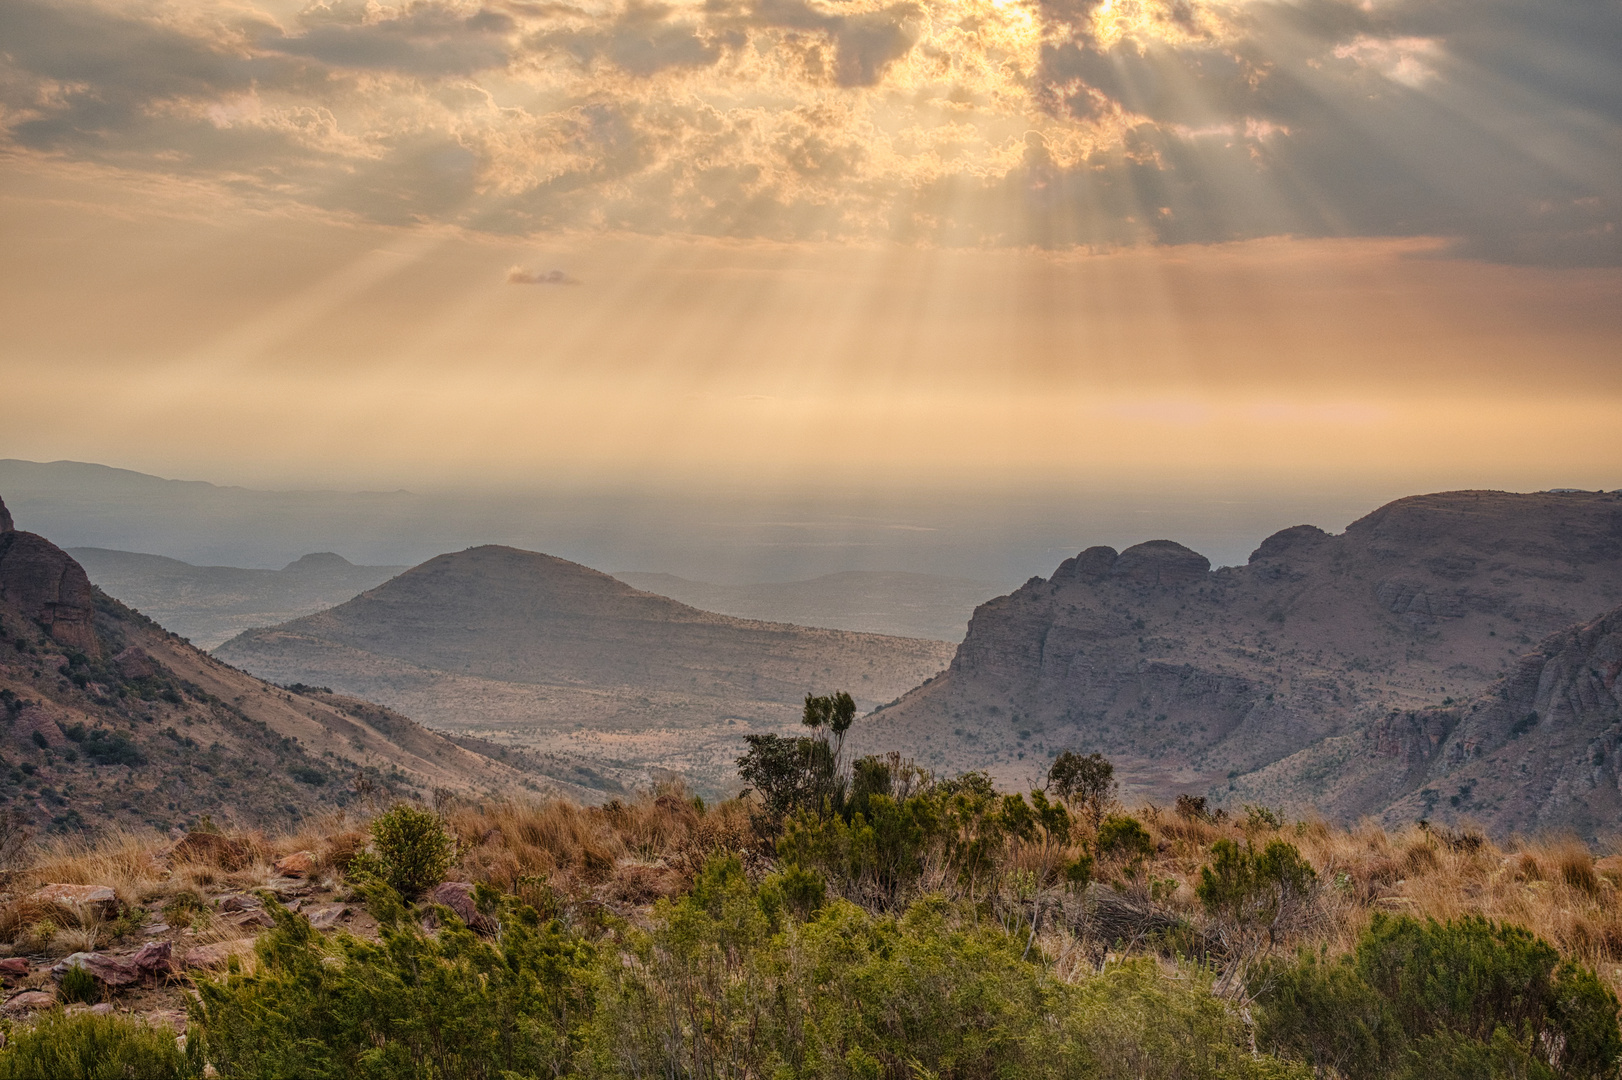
[0,697,1622,1080]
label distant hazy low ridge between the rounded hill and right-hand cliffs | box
[615,571,998,642]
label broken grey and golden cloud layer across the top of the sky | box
[0,0,1622,264]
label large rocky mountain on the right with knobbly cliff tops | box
[858,491,1622,814]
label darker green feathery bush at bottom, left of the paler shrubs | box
[191,882,594,1080]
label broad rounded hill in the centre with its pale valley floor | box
[214,546,952,791]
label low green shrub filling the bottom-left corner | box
[0,1012,196,1080]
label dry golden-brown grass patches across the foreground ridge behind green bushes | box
[12,786,1622,991]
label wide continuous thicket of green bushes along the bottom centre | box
[180,858,1307,1080]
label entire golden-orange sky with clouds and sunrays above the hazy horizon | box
[0,0,1622,569]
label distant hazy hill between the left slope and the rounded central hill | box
[68,548,406,649]
